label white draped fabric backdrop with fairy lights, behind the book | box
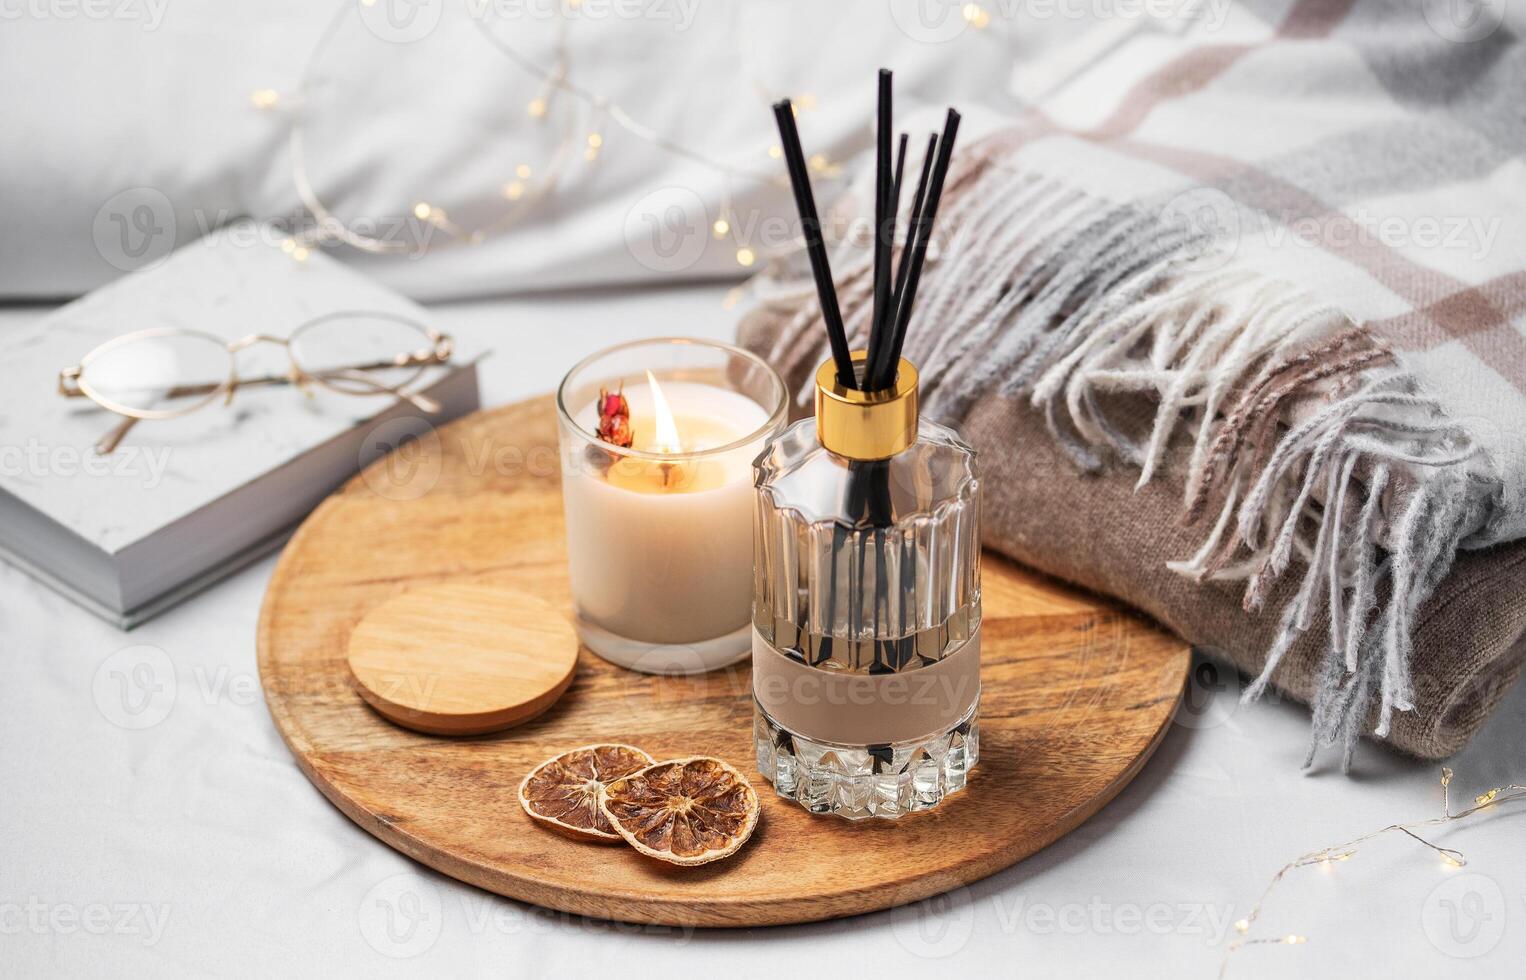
[0,0,1037,299]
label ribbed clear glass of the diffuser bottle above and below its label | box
[752,418,980,820]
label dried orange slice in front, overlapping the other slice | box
[598,756,758,864]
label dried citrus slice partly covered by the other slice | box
[519,745,652,841]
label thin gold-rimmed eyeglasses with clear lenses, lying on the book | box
[58,311,453,455]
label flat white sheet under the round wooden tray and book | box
[0,287,1526,980]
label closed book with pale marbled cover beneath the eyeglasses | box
[0,223,479,629]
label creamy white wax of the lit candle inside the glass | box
[562,382,768,644]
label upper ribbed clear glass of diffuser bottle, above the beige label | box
[752,418,980,673]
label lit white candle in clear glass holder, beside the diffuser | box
[557,337,787,673]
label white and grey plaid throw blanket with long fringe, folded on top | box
[745,0,1526,763]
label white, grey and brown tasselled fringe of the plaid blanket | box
[763,166,1488,766]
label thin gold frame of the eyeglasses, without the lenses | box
[58,310,455,455]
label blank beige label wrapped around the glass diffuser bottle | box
[752,629,980,745]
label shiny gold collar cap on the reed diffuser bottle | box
[816,351,917,459]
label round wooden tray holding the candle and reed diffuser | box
[258,398,1189,927]
